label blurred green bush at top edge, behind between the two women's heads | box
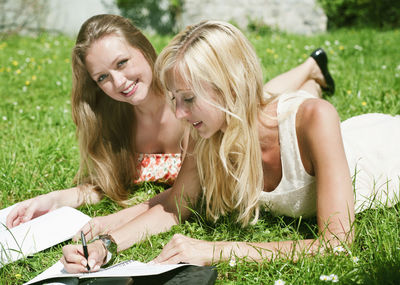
[117,0,183,34]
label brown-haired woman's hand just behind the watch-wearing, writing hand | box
[73,215,115,241]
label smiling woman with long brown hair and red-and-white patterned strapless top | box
[7,15,334,235]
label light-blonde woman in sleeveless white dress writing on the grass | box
[62,21,400,272]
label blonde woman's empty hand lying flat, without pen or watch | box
[153,234,219,265]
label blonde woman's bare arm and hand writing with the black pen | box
[61,141,200,272]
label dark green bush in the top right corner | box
[318,0,400,29]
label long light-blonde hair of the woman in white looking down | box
[155,21,267,225]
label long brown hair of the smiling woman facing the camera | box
[71,14,162,205]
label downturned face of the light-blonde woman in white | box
[171,72,226,139]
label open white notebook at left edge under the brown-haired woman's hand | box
[0,205,91,268]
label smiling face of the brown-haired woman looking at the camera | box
[86,34,153,105]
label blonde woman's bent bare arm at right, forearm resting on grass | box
[155,99,354,265]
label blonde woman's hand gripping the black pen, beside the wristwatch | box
[60,240,107,273]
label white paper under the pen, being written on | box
[24,260,188,285]
